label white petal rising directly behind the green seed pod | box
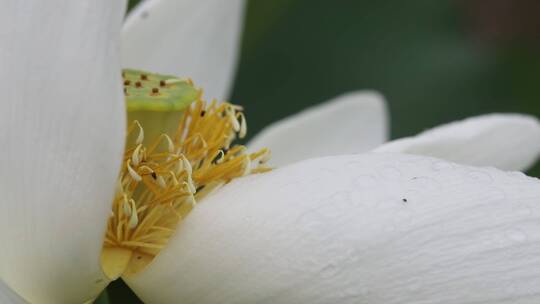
[122,0,245,100]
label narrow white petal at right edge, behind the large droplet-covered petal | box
[375,114,540,170]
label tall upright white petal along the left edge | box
[0,0,125,303]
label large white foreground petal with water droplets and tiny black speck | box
[124,153,540,304]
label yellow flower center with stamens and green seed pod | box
[101,71,270,280]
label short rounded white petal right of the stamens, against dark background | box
[248,91,388,166]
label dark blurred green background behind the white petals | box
[103,0,540,303]
